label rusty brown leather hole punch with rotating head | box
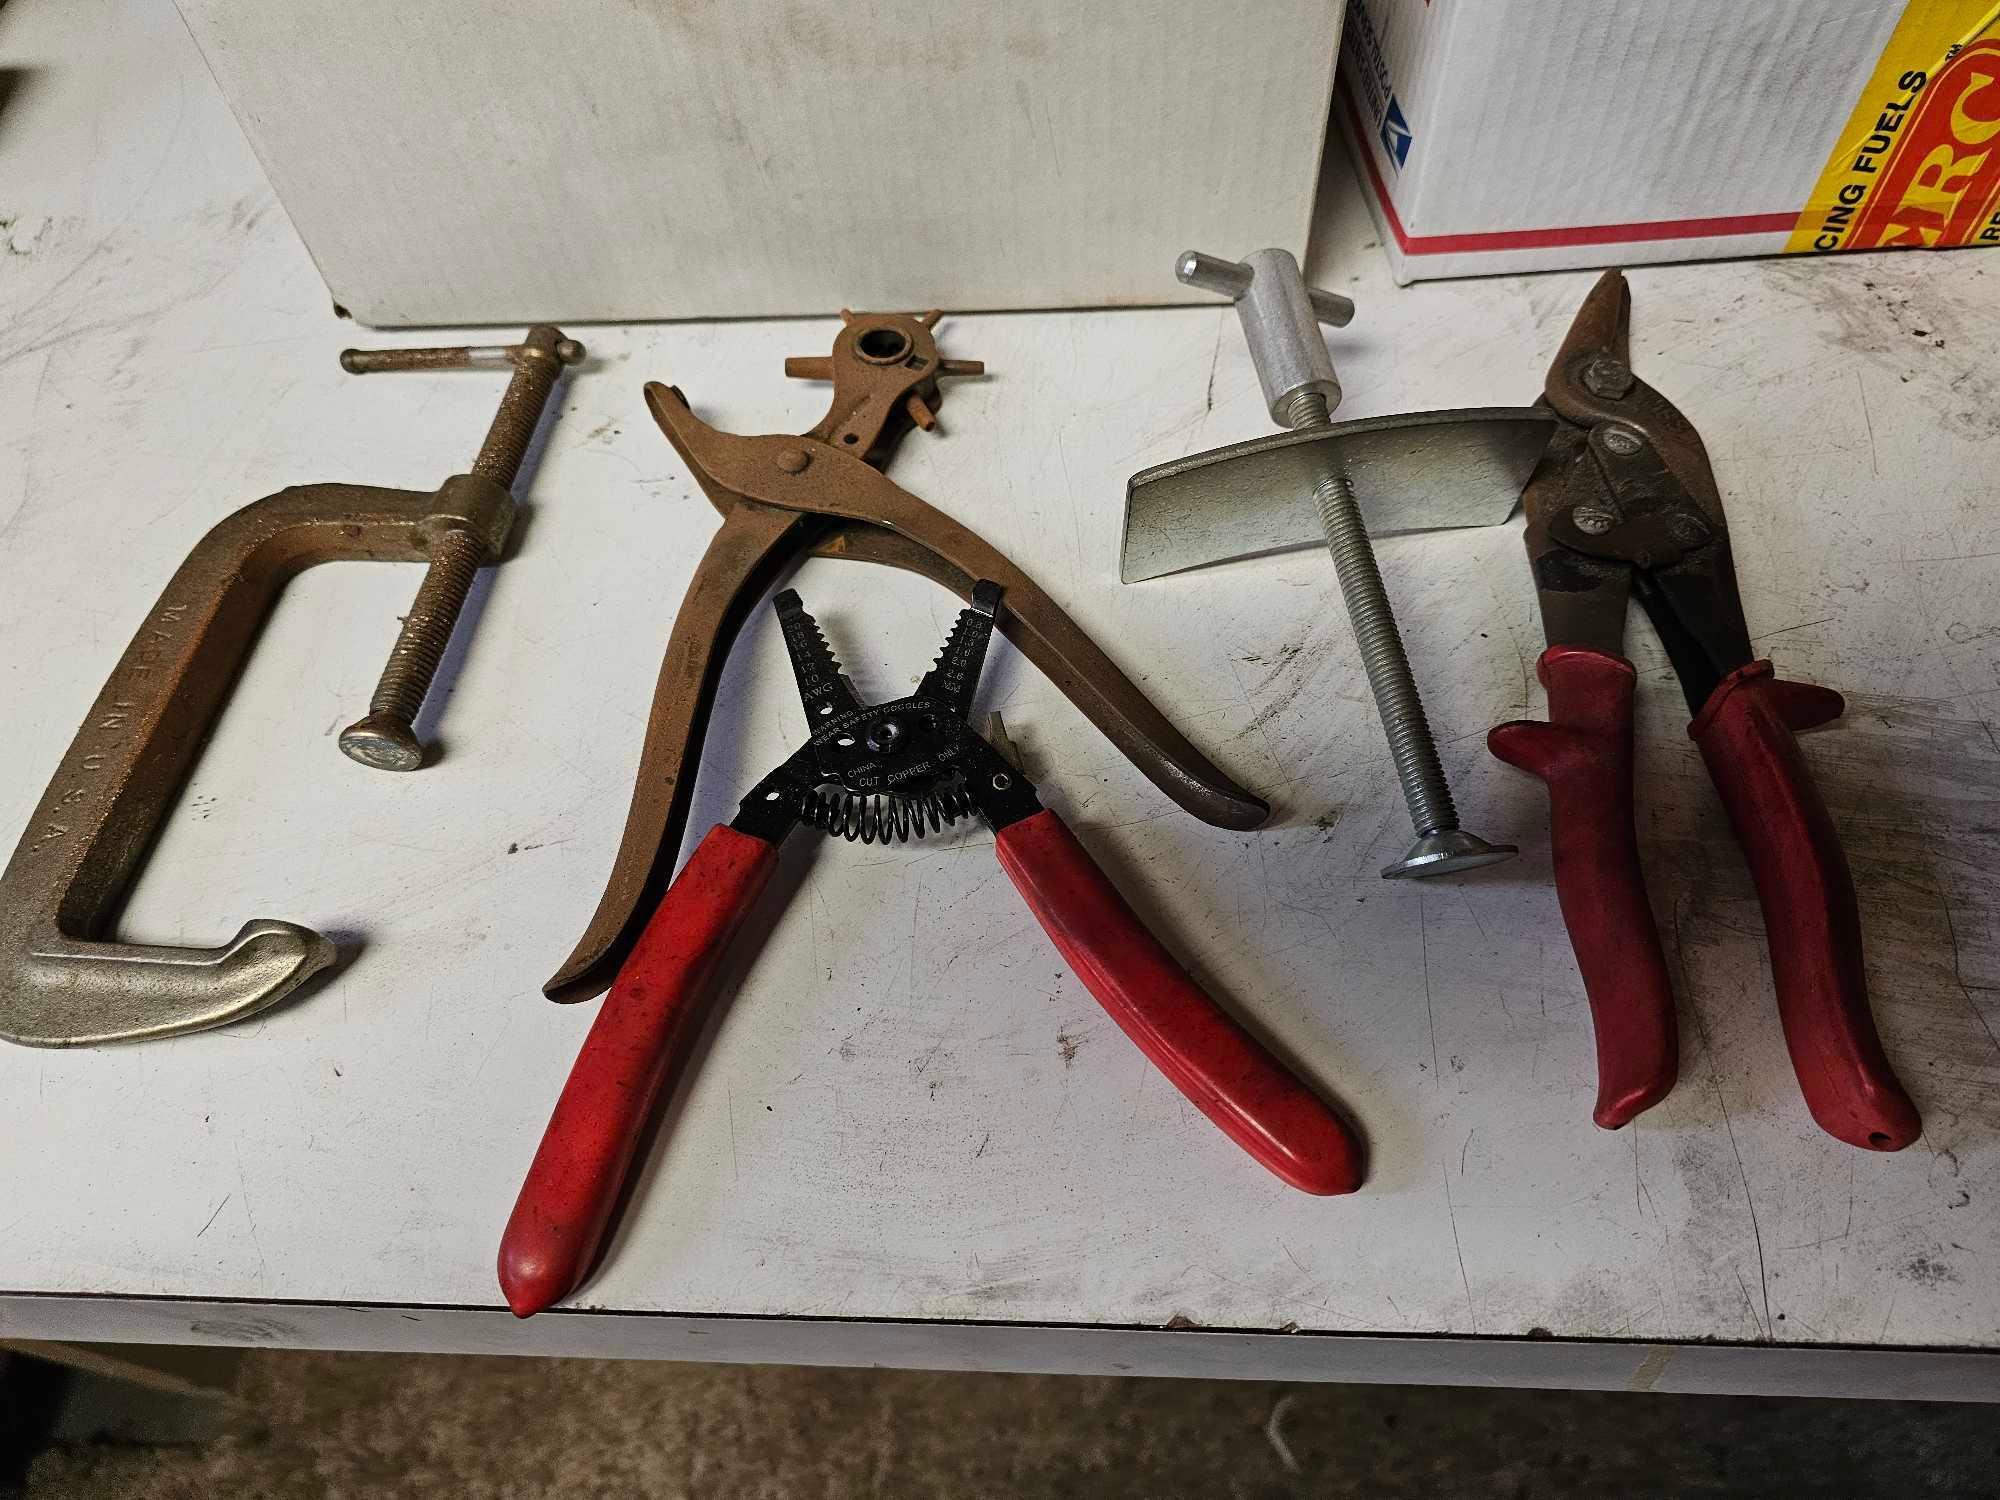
[542,312,1270,1000]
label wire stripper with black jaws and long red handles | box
[500,580,1362,1318]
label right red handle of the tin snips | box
[1688,662,1924,1152]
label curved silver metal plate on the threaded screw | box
[1118,406,1556,584]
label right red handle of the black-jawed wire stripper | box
[996,808,1364,1194]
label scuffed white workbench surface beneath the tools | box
[0,0,2000,1394]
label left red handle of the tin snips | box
[1486,646,1680,1130]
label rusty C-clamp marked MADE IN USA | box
[0,328,582,1046]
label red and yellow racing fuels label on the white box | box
[1786,0,2000,252]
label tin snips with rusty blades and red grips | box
[1488,272,1922,1152]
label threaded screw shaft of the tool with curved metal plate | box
[1284,390,1458,836]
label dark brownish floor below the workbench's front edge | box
[0,1352,2000,1500]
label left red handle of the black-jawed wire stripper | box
[500,824,778,1318]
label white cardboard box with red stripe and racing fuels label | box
[1336,0,2000,282]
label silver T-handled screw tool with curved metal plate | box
[1120,250,1554,876]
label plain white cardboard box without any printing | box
[178,0,1340,324]
